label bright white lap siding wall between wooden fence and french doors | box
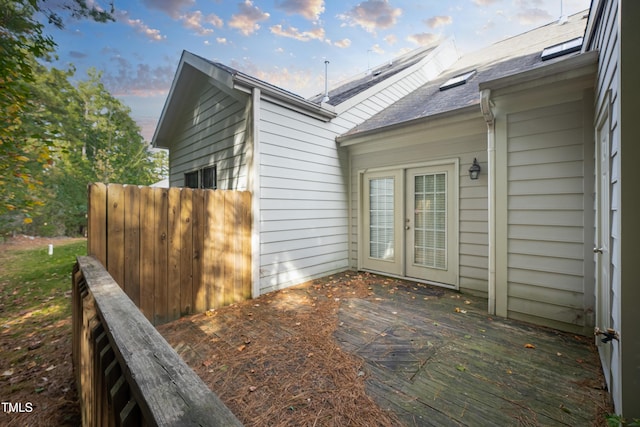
[260,102,348,293]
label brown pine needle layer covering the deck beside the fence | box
[158,272,416,427]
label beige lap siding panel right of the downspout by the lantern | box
[507,101,591,329]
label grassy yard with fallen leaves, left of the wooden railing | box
[0,238,86,426]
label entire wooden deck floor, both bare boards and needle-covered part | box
[160,272,607,426]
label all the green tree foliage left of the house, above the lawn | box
[0,0,166,235]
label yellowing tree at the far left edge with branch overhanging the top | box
[0,0,113,222]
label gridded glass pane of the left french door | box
[369,178,395,260]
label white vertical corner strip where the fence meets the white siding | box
[249,88,261,298]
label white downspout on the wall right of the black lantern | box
[480,89,496,314]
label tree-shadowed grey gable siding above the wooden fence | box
[169,86,250,190]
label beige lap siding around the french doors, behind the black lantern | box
[349,119,488,295]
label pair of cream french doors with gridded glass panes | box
[361,163,458,287]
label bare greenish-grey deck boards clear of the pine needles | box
[335,284,606,426]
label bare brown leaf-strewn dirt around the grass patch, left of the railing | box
[0,236,80,426]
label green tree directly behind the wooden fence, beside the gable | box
[24,67,162,235]
